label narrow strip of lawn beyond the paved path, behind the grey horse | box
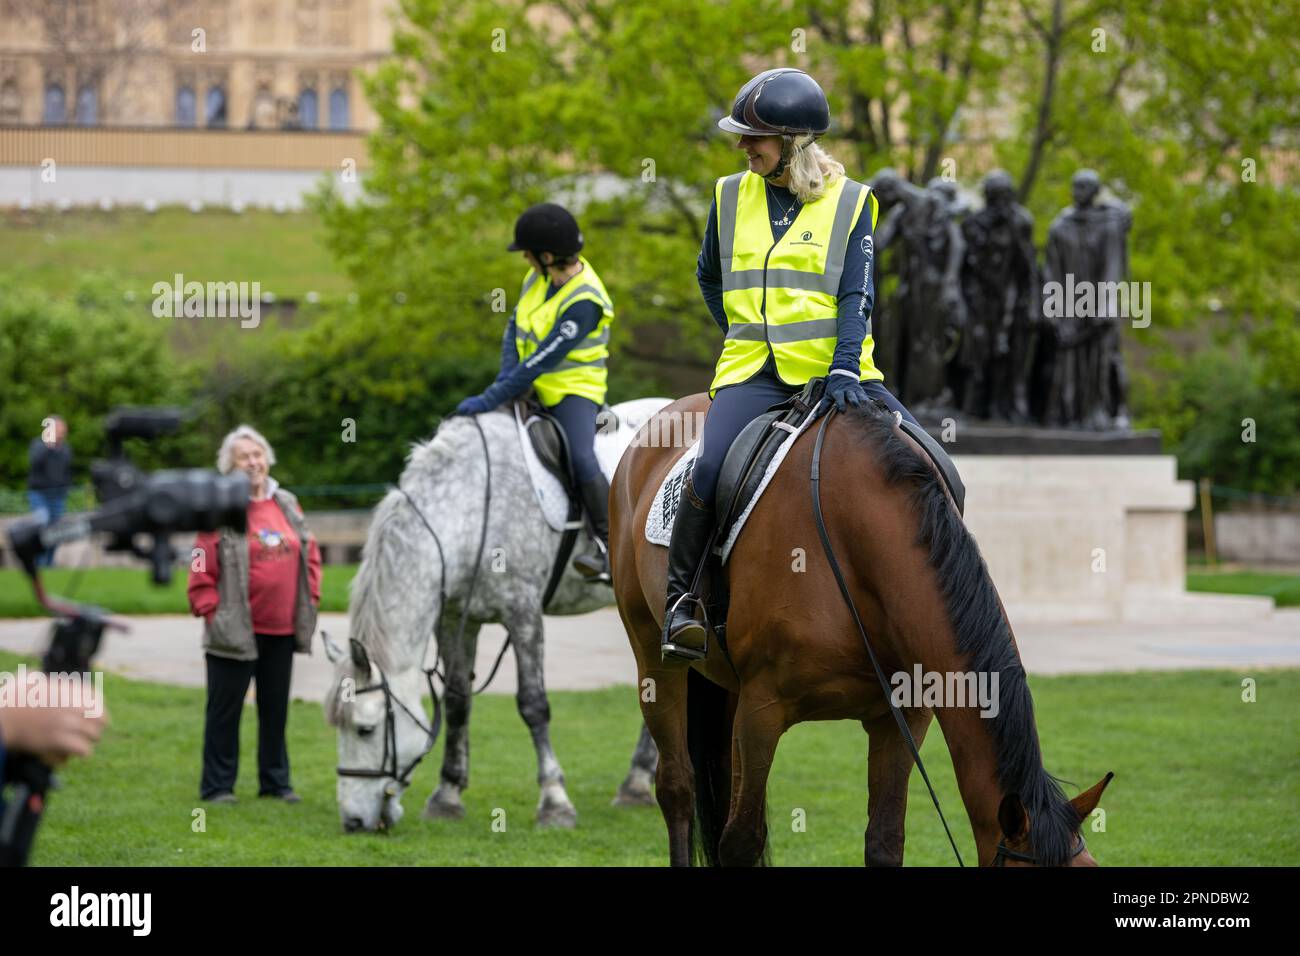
[0,564,1300,618]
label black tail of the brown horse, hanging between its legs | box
[686,670,771,866]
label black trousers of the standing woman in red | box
[199,633,294,800]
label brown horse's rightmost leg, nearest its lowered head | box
[862,708,935,866]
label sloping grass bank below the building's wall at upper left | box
[0,207,351,303]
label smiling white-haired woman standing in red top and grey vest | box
[189,425,321,804]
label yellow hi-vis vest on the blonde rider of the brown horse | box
[709,170,884,395]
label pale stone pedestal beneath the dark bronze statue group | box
[953,455,1273,624]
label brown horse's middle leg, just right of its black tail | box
[718,684,785,866]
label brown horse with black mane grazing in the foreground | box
[610,395,1110,866]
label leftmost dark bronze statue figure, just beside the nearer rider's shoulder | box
[871,169,962,412]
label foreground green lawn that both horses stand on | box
[0,654,1300,866]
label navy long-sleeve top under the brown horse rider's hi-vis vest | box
[696,183,875,375]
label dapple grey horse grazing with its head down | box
[325,399,664,831]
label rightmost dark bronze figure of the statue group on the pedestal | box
[1043,169,1132,429]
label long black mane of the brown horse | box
[845,403,1080,866]
